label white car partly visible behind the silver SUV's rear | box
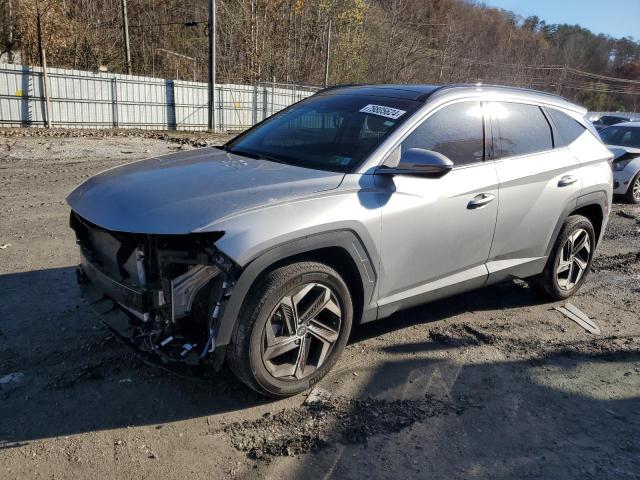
[600,121,640,204]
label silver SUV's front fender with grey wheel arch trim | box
[210,175,384,345]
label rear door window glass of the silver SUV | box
[489,102,553,158]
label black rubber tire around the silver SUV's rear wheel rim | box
[529,215,596,300]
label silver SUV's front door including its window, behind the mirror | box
[377,101,498,316]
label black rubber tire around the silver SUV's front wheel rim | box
[227,262,353,398]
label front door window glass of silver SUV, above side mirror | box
[401,102,484,165]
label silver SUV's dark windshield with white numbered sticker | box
[225,95,421,172]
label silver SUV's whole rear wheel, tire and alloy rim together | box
[530,215,596,300]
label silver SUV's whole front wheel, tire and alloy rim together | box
[227,262,353,397]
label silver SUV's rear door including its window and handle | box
[487,102,582,281]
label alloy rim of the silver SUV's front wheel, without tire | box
[261,283,342,380]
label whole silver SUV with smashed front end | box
[67,85,612,396]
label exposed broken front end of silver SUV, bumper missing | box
[71,212,239,365]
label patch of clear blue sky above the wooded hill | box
[484,0,640,40]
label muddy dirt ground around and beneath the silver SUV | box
[0,130,640,480]
